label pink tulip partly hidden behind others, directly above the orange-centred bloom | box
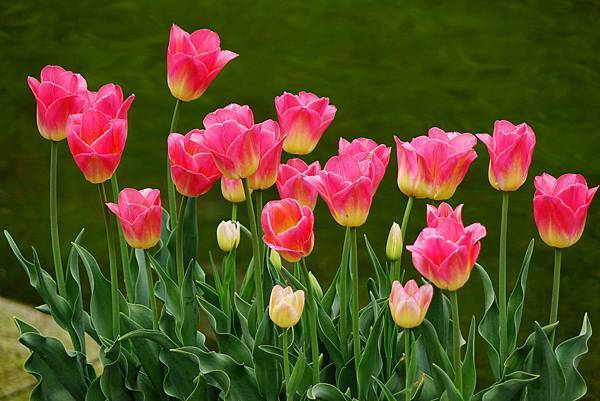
[277,159,321,210]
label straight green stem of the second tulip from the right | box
[498,192,509,366]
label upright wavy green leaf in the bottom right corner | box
[556,313,592,401]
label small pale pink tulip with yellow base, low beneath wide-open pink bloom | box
[388,280,433,329]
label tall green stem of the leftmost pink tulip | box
[50,141,67,297]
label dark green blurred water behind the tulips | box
[0,0,600,399]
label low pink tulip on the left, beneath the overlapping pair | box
[106,188,162,249]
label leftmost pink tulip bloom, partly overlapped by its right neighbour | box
[27,65,87,141]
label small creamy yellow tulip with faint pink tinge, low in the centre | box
[269,284,304,329]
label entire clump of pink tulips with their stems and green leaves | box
[5,25,598,401]
